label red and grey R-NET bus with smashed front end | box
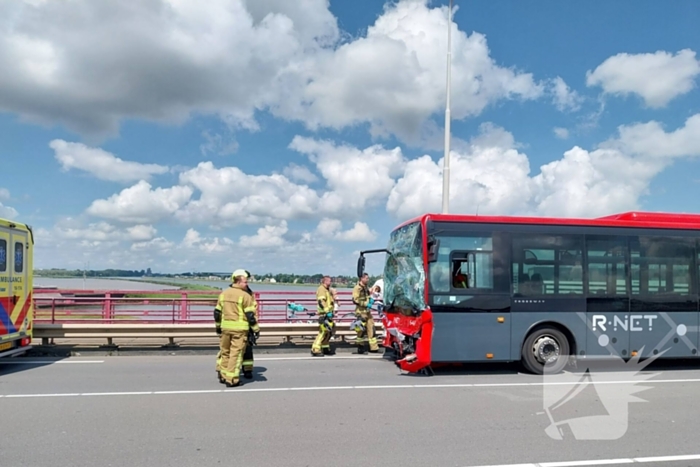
[358,212,700,374]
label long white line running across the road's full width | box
[0,378,700,400]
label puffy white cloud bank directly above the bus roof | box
[387,114,700,219]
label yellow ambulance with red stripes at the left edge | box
[0,219,34,357]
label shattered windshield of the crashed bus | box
[384,222,426,314]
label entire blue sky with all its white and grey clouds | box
[0,0,700,274]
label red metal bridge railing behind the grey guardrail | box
[33,289,379,324]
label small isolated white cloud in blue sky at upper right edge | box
[587,49,700,108]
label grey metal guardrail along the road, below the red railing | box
[34,321,383,345]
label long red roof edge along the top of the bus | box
[396,211,700,230]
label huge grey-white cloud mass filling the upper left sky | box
[0,0,545,146]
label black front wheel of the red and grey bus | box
[522,327,570,375]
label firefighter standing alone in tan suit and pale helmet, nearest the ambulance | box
[215,269,260,387]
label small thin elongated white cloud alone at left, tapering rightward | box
[49,139,168,182]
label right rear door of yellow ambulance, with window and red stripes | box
[8,230,32,338]
